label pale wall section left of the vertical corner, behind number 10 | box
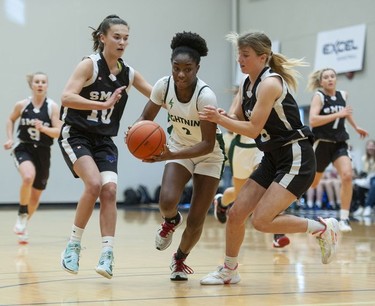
[0,0,231,203]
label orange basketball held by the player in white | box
[126,120,166,159]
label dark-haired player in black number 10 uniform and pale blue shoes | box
[59,15,152,278]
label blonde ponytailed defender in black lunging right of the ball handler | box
[200,32,339,285]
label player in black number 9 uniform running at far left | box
[4,72,61,244]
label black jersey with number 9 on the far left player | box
[17,98,54,147]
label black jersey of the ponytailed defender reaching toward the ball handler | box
[242,67,313,152]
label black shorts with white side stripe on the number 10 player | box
[58,125,118,178]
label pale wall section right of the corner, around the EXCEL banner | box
[239,0,375,167]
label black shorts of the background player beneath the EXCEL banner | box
[314,139,350,173]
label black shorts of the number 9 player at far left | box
[12,142,51,190]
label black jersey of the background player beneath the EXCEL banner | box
[312,90,349,142]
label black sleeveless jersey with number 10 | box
[60,53,130,136]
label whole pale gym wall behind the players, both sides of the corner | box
[0,0,375,203]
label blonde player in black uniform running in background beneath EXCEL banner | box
[308,68,368,232]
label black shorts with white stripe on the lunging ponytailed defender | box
[250,139,316,198]
